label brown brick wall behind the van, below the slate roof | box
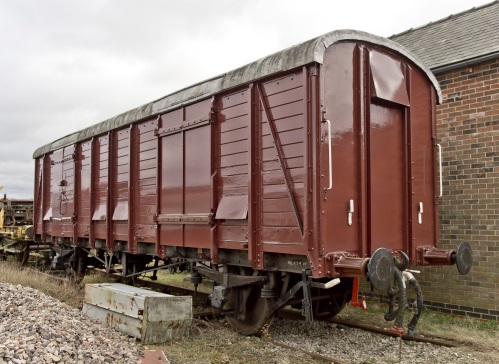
[363,58,499,320]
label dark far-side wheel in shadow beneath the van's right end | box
[312,278,352,320]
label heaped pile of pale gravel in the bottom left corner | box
[0,283,141,364]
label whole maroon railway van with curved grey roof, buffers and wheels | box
[34,30,472,334]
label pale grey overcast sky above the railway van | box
[0,0,490,198]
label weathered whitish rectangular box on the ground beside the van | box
[83,283,192,344]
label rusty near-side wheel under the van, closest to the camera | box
[226,269,273,335]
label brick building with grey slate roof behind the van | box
[391,1,499,320]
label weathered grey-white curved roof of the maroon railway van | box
[33,30,442,158]
